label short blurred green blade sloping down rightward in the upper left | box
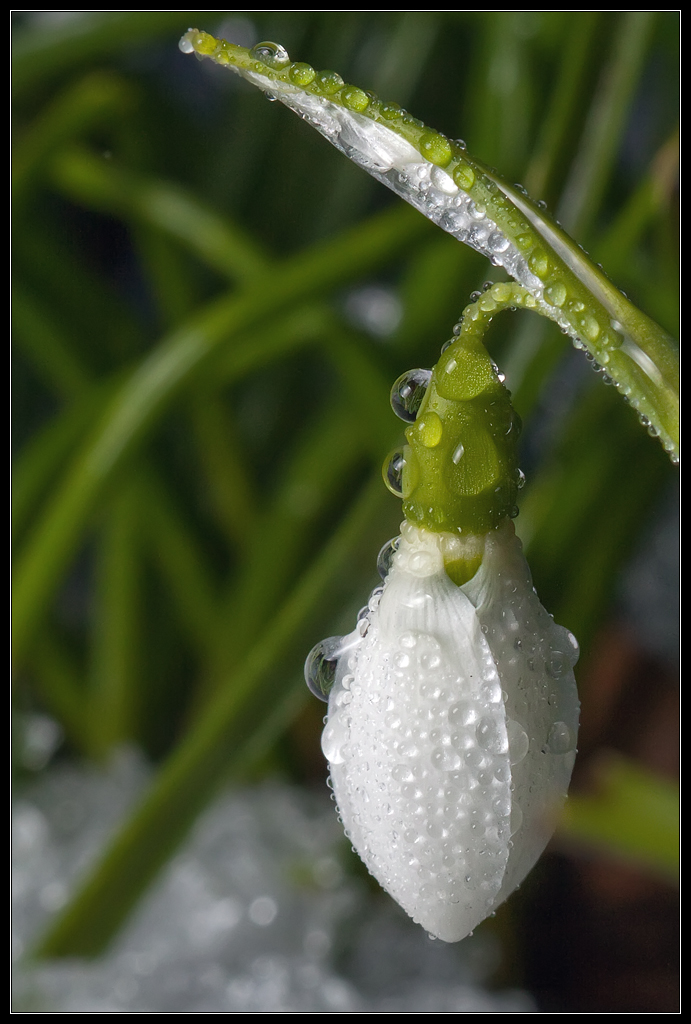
[52,146,269,283]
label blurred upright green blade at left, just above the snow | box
[89,475,142,759]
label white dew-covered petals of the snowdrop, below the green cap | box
[322,523,578,942]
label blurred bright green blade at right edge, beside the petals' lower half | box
[559,753,680,883]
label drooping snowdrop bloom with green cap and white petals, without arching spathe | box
[305,285,578,942]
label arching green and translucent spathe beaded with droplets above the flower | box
[180,27,679,460]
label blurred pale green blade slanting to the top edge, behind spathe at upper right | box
[557,10,656,239]
